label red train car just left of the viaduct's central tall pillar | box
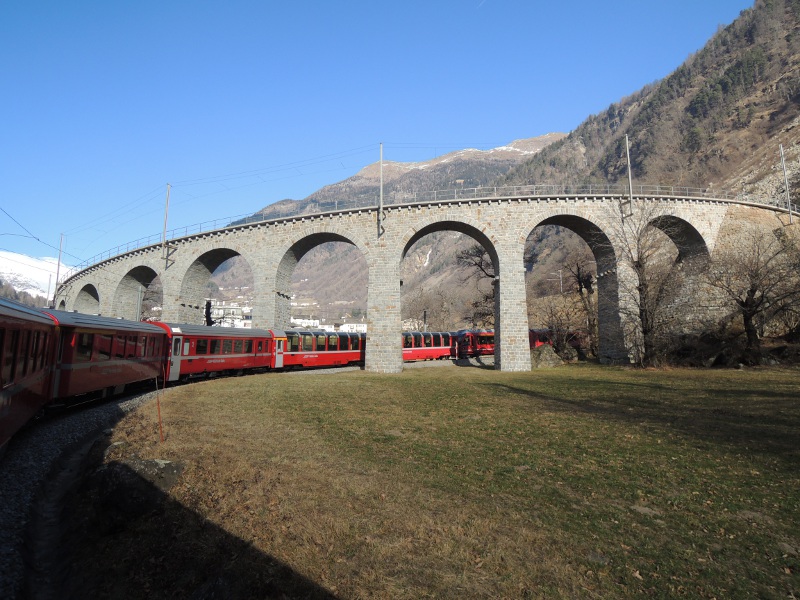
[283,330,366,368]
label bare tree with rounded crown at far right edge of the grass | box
[707,225,800,364]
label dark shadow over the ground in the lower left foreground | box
[27,438,336,600]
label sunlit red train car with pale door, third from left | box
[154,323,286,381]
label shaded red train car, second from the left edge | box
[42,309,166,398]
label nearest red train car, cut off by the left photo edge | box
[0,299,56,454]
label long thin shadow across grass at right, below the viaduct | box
[488,379,800,471]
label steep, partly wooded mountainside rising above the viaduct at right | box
[499,0,800,197]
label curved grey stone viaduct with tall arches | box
[56,193,788,372]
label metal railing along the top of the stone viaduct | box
[62,184,800,283]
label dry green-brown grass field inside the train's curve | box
[73,365,800,599]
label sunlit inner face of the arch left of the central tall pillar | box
[272,228,370,328]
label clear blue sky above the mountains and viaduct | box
[0,0,752,264]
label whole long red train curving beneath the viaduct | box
[0,292,572,453]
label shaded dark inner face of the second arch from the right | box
[526,213,628,362]
